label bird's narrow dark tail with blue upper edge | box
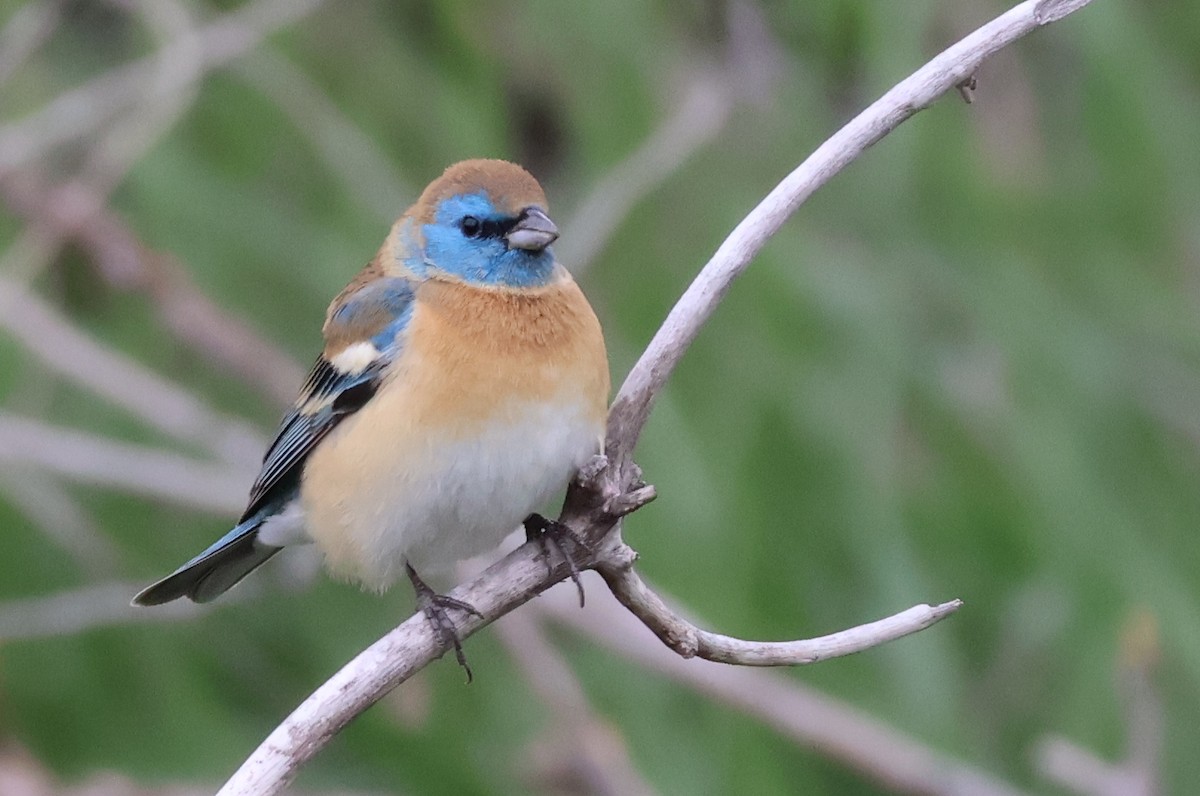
[133,519,283,605]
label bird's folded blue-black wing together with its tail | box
[133,273,413,605]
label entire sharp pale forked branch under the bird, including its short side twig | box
[220,0,1088,796]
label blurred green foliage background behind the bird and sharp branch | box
[0,0,1200,796]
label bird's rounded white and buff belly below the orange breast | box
[301,401,604,589]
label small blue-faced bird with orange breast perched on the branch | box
[133,160,610,681]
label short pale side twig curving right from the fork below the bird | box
[596,544,962,666]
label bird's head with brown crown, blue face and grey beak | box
[408,160,558,288]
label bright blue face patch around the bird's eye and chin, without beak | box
[422,192,554,287]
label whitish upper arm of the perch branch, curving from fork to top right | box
[605,0,1090,478]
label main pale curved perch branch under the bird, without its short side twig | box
[221,0,1086,796]
